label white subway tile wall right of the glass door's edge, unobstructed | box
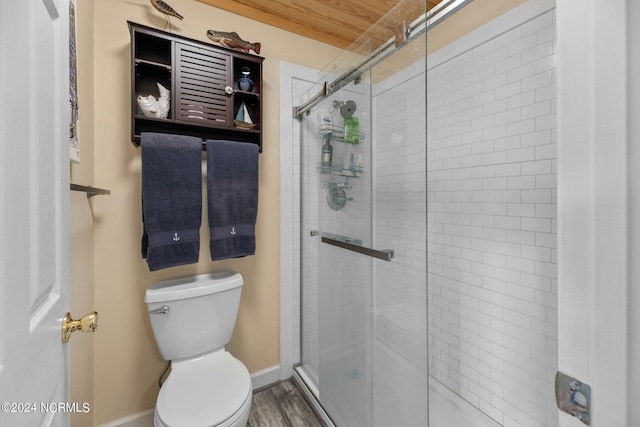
[427,11,558,427]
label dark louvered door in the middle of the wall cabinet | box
[175,43,232,126]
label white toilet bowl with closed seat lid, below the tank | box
[154,350,252,427]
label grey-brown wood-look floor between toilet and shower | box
[247,380,325,427]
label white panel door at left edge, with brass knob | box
[0,0,71,427]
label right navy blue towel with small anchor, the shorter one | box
[207,140,259,261]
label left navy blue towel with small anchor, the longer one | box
[140,132,202,271]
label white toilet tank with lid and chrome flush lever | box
[144,270,243,360]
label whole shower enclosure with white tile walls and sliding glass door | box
[294,0,558,427]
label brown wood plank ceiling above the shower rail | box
[198,0,442,48]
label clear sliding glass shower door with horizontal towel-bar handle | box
[298,0,428,427]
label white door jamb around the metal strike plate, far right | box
[558,0,640,427]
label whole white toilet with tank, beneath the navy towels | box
[144,271,252,427]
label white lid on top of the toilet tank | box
[144,270,243,303]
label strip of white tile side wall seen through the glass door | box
[373,67,427,379]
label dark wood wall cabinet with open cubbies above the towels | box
[128,21,264,151]
